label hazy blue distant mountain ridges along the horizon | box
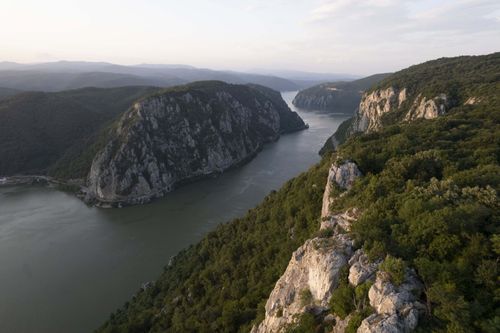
[0,61,354,92]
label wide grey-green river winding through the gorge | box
[0,92,347,333]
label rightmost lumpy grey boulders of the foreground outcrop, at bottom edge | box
[358,270,423,333]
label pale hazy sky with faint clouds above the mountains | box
[0,0,500,74]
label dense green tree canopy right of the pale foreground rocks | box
[333,83,500,331]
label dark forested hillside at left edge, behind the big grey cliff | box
[0,87,158,177]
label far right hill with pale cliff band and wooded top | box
[325,53,500,149]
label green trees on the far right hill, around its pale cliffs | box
[321,52,500,150]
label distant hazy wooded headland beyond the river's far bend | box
[293,74,390,113]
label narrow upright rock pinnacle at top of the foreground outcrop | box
[321,161,362,218]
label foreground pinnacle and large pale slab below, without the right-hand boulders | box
[252,161,361,333]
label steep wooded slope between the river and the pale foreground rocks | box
[98,159,329,332]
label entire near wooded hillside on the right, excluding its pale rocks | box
[98,56,500,333]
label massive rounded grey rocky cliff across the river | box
[87,82,305,205]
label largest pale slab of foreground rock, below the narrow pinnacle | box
[252,234,352,333]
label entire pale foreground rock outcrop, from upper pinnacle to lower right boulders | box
[252,161,424,333]
